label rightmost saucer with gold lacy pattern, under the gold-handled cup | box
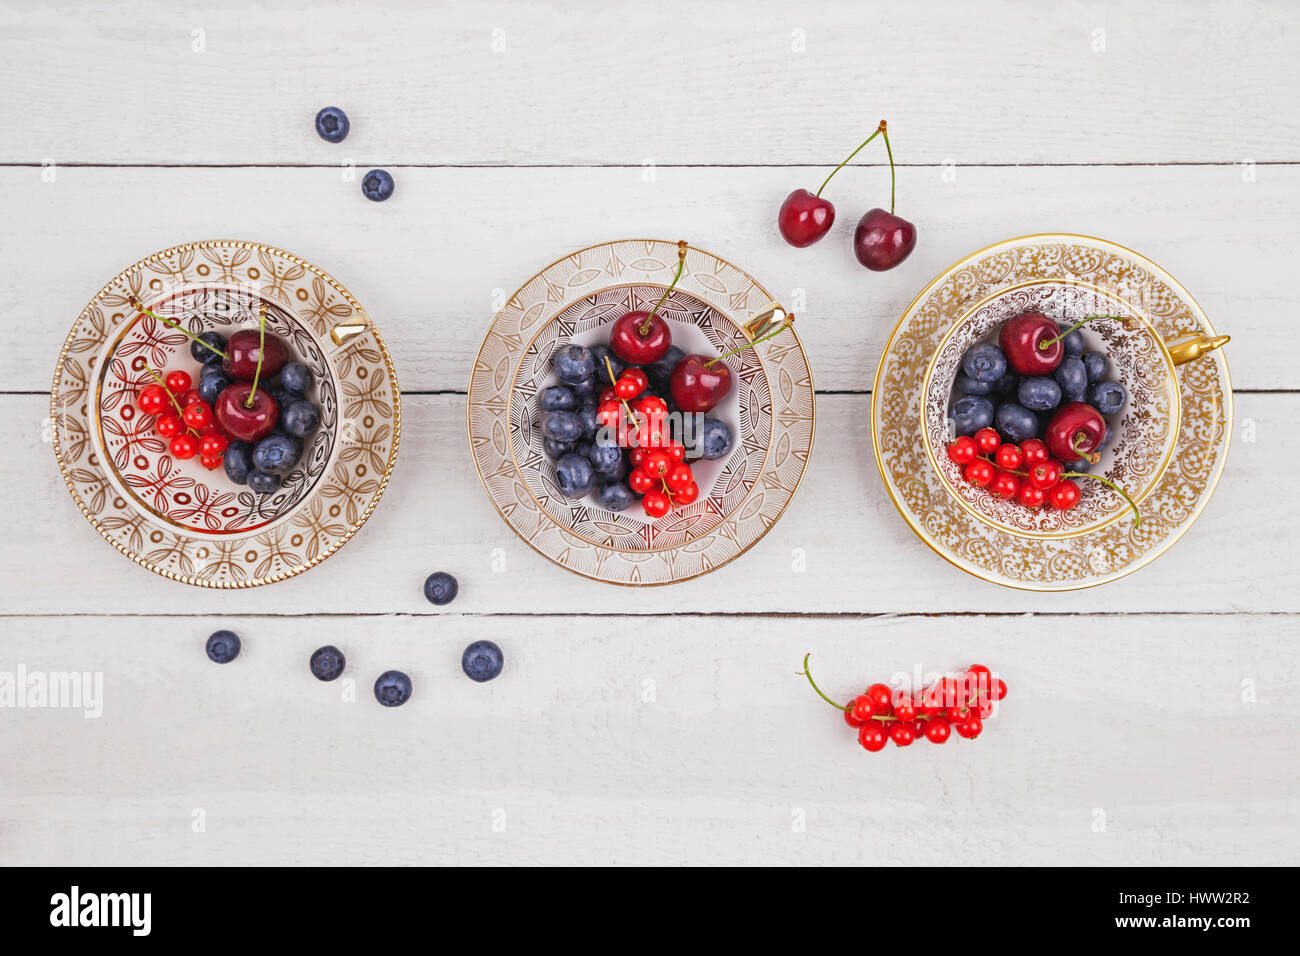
[871,234,1232,591]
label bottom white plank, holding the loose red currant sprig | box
[0,614,1300,866]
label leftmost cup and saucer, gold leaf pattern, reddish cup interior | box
[51,241,402,588]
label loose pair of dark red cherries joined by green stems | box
[776,120,917,272]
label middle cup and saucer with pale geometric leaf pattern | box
[468,239,815,585]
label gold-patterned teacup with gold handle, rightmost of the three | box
[920,281,1229,538]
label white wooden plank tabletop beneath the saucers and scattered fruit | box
[0,0,1300,864]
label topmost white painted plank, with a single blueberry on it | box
[0,0,1300,165]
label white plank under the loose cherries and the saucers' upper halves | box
[0,166,1300,390]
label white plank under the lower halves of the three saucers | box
[0,394,1300,613]
